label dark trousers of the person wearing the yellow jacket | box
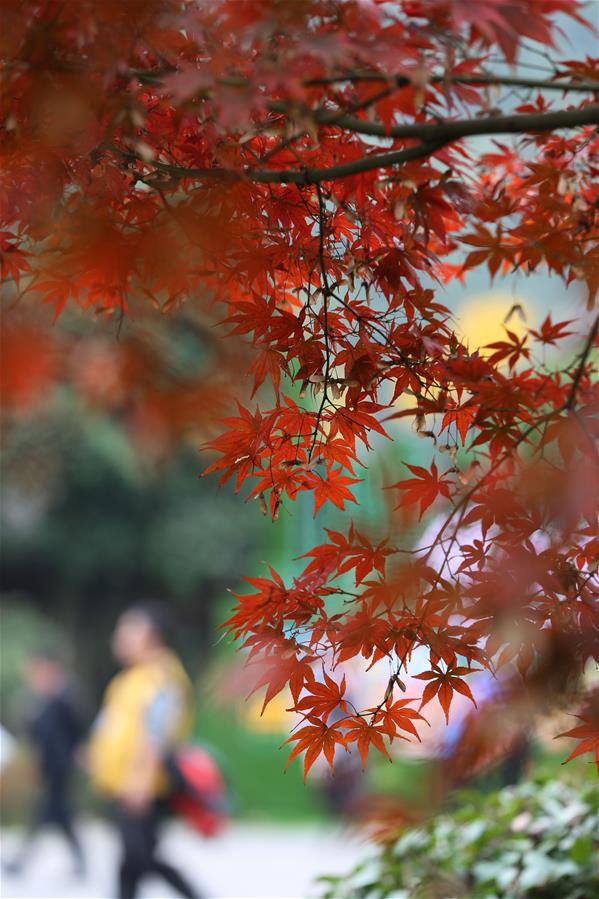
[116,802,199,899]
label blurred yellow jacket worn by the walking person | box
[89,650,191,797]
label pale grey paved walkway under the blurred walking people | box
[0,821,365,899]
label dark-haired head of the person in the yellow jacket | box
[112,600,173,665]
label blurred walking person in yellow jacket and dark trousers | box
[88,602,198,899]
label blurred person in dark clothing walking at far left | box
[5,652,85,876]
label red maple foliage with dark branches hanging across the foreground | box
[0,0,599,788]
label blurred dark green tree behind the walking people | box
[0,388,262,688]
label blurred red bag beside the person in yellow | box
[170,746,229,837]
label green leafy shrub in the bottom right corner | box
[323,780,599,899]
